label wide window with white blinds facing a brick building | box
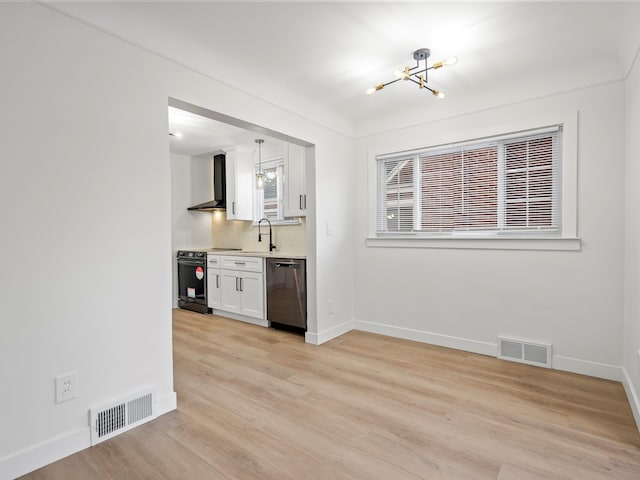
[376,126,562,235]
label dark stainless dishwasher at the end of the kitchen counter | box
[266,258,307,331]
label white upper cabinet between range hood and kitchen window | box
[225,148,254,220]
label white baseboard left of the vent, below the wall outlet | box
[0,425,91,480]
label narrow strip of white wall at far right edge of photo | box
[623,56,640,425]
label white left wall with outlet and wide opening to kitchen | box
[0,3,353,479]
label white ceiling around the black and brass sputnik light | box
[42,1,640,154]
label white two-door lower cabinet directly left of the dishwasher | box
[217,256,265,320]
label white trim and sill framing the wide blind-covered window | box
[366,107,580,250]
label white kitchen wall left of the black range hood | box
[170,153,213,308]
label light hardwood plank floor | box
[24,310,640,480]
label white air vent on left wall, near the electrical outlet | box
[89,390,155,445]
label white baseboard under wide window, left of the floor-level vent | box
[354,320,498,357]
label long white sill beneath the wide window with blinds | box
[365,237,581,251]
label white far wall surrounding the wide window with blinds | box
[355,82,624,379]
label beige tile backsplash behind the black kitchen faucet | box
[211,212,307,255]
